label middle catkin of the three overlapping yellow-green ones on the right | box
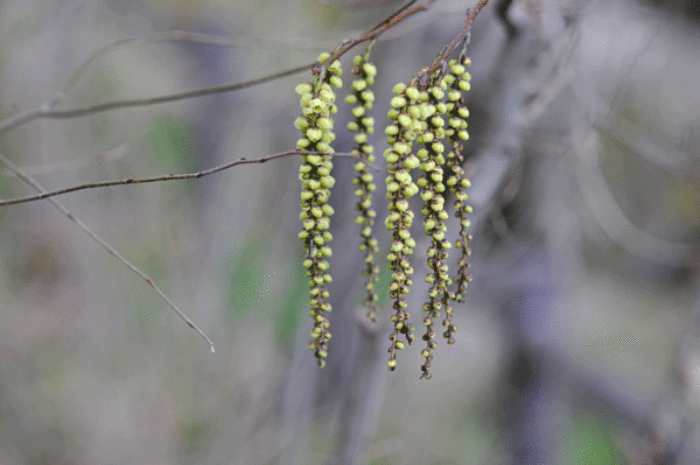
[416,71,452,379]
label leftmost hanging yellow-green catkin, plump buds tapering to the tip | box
[295,53,342,367]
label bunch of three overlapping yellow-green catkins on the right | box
[385,55,471,379]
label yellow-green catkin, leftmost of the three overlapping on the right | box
[384,83,430,370]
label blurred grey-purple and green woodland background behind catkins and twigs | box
[0,0,700,465]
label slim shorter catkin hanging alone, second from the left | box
[345,47,379,321]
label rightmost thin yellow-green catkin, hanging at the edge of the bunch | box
[442,55,472,344]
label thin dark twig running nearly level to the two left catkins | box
[0,149,372,207]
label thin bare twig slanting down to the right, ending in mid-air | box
[0,153,214,352]
